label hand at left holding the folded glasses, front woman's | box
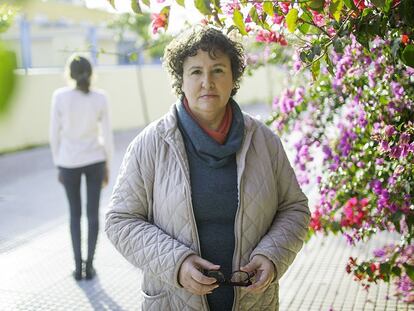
[178,255,220,295]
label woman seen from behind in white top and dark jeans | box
[50,55,113,280]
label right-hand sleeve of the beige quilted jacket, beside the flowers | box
[250,135,310,279]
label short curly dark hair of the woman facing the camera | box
[163,26,246,97]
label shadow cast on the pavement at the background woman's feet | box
[78,276,124,311]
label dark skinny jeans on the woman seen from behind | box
[59,162,105,268]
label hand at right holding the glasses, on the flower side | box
[240,255,276,293]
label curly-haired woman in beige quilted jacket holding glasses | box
[105,26,309,311]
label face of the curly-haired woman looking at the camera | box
[182,50,234,121]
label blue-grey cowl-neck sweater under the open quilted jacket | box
[177,101,244,311]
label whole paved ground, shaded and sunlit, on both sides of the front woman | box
[0,105,414,311]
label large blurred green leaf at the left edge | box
[0,45,17,115]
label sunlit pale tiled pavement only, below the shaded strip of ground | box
[0,222,414,311]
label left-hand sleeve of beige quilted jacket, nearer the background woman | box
[105,133,194,287]
